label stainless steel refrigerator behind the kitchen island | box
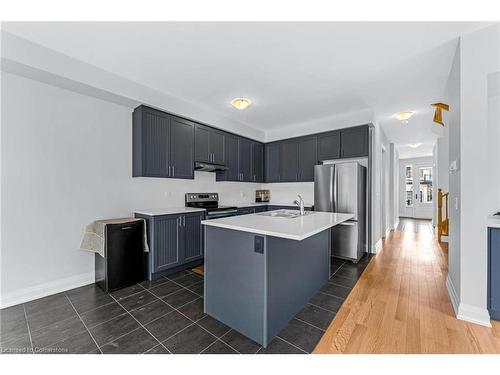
[314,162,367,263]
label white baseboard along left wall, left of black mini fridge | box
[0,272,95,308]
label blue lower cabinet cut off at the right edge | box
[488,228,500,320]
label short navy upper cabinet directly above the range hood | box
[195,124,226,165]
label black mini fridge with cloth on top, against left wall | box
[95,220,147,292]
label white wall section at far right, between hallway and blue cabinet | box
[458,24,500,325]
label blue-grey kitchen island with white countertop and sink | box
[202,210,353,347]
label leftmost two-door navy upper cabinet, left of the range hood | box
[132,106,194,179]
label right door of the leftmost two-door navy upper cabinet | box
[170,117,194,178]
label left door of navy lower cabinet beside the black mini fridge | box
[155,216,181,272]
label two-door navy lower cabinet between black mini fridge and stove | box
[135,212,205,280]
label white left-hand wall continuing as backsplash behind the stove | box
[0,73,260,306]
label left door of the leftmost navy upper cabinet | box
[139,109,170,177]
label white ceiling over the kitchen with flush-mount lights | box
[2,22,487,143]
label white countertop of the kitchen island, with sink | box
[201,211,354,241]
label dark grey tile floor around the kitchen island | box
[0,256,370,354]
